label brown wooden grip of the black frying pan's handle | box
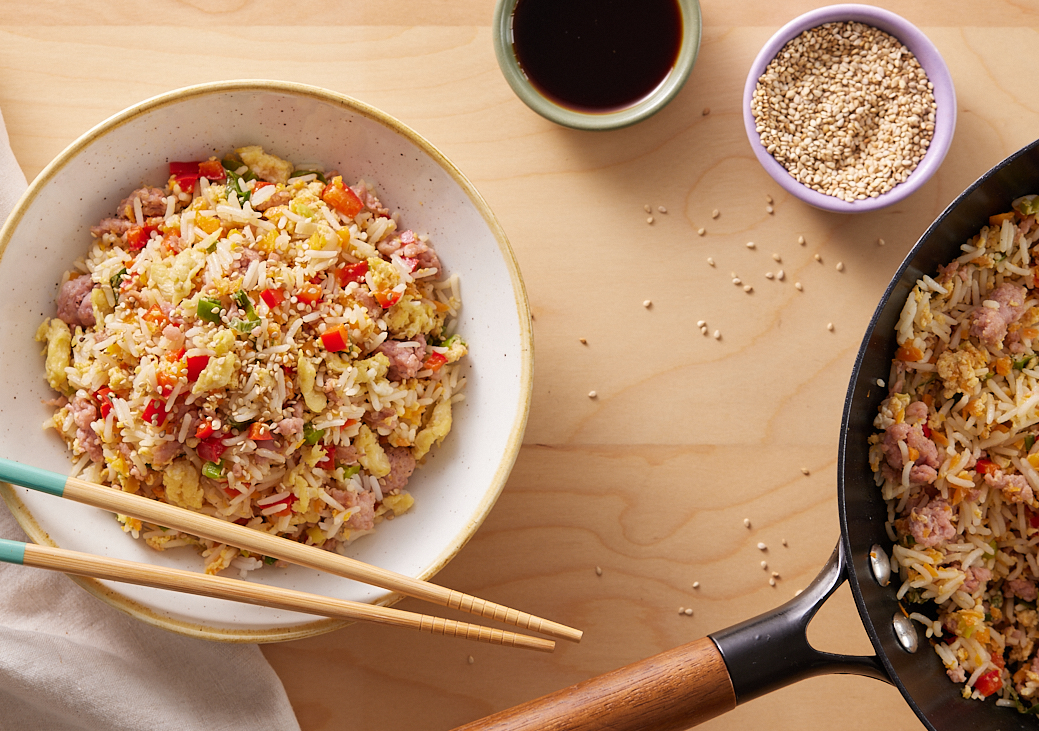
[455,638,736,731]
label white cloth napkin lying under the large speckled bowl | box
[0,108,299,731]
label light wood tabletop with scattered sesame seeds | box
[0,0,1039,731]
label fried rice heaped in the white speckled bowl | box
[36,145,467,573]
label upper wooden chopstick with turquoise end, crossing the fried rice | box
[0,458,583,642]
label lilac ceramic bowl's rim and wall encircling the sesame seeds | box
[743,4,956,213]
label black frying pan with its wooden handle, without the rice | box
[456,141,1039,731]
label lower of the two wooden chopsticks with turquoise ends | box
[0,538,556,652]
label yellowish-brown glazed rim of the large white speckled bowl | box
[0,79,534,643]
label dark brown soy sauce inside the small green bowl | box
[512,0,682,112]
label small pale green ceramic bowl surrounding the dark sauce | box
[491,0,701,131]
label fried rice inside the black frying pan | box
[870,195,1039,713]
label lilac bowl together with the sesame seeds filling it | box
[743,4,956,213]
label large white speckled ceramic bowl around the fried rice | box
[0,81,533,642]
